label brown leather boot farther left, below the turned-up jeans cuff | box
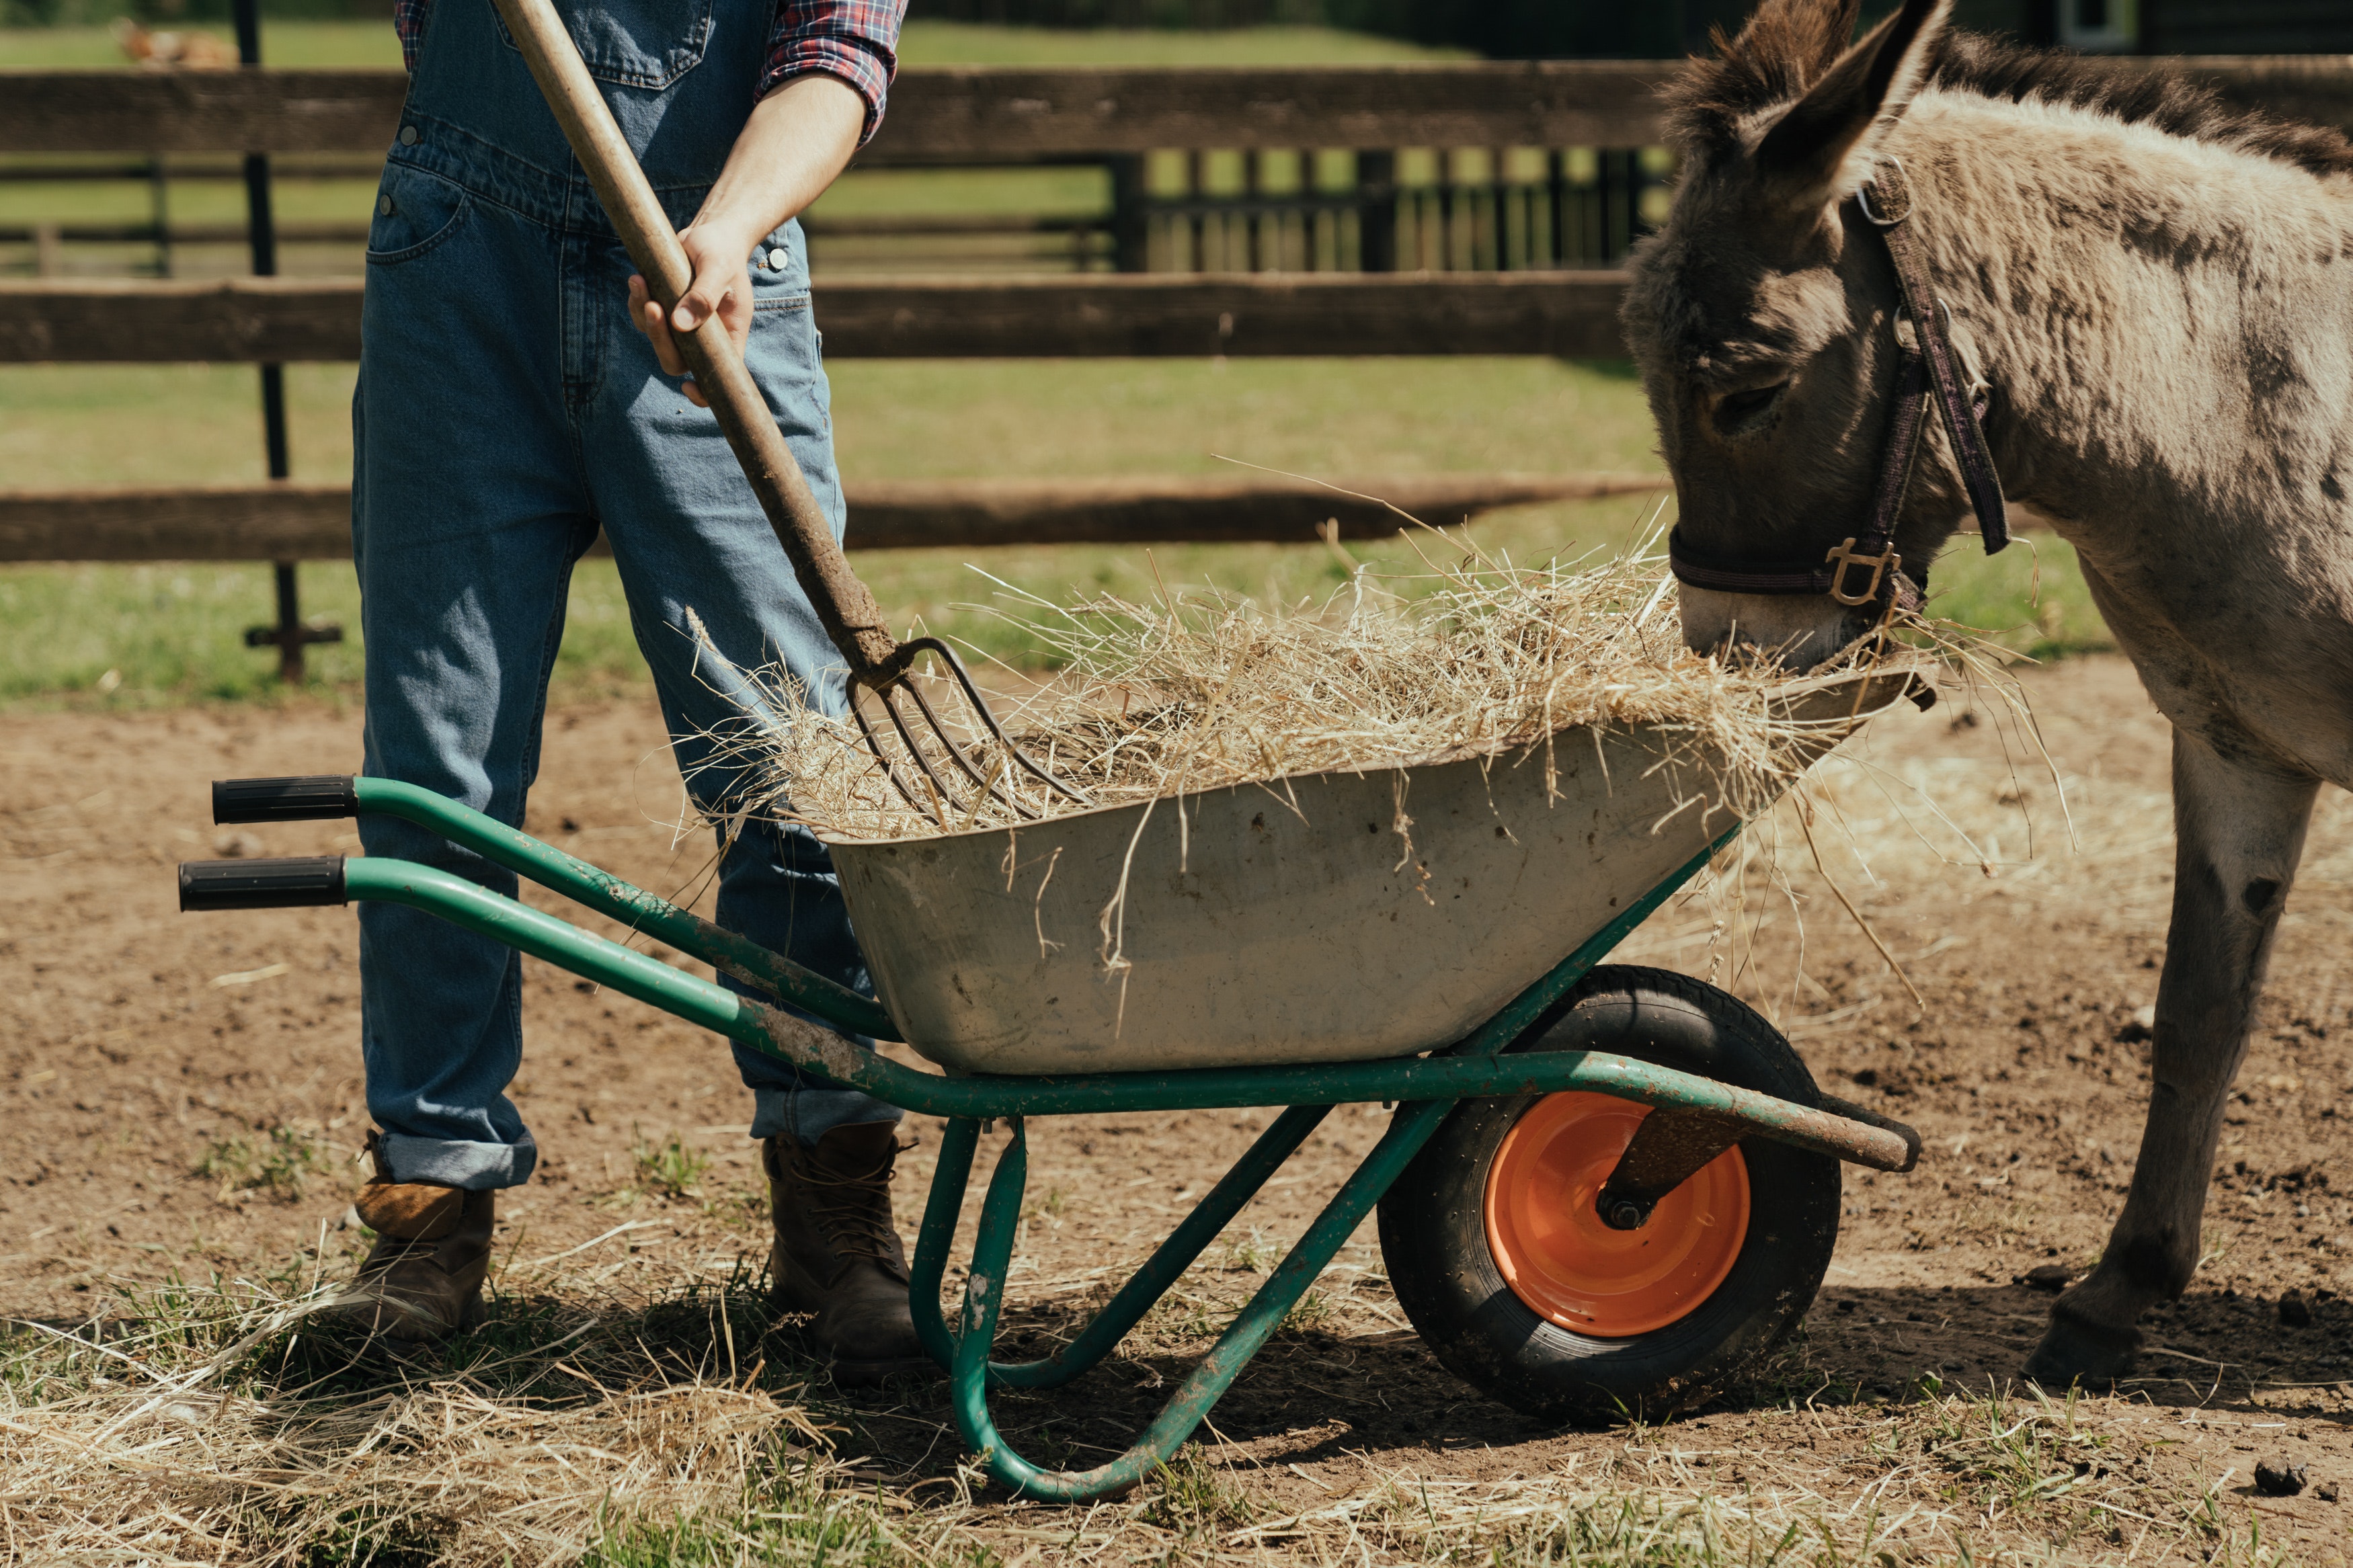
[334,1138,499,1347]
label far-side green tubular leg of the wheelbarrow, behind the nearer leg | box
[908,1105,1332,1389]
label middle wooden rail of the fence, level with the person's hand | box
[0,273,1626,364]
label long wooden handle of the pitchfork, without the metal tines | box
[494,0,913,689]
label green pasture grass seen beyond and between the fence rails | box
[0,21,2106,710]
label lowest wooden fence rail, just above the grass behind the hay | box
[0,472,1666,562]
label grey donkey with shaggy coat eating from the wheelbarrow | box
[1626,0,2353,1383]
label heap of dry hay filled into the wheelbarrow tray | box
[701,536,1925,839]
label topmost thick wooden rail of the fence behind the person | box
[0,54,2353,165]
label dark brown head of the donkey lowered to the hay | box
[1624,0,1960,670]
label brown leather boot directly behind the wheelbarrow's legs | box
[760,1121,939,1387]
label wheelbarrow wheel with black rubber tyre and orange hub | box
[1382,966,1840,1420]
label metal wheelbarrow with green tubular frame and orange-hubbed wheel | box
[179,677,1920,1502]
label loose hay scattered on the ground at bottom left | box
[0,1284,927,1566]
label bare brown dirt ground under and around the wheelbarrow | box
[13,658,2353,1563]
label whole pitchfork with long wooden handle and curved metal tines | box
[494,0,1087,827]
